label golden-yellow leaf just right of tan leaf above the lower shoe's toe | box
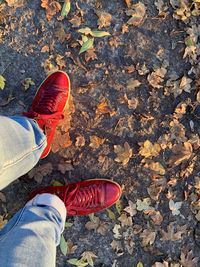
[139,140,161,158]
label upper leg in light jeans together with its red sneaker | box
[0,71,70,190]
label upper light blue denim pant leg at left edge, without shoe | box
[0,116,46,190]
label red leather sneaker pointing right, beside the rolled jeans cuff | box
[30,179,122,216]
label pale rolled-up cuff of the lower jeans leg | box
[26,193,67,222]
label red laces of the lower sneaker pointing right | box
[64,184,104,213]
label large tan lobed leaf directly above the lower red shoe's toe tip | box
[114,142,133,165]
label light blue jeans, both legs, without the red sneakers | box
[0,116,66,267]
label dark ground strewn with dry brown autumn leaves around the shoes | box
[0,0,200,267]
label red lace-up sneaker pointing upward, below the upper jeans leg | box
[23,71,70,158]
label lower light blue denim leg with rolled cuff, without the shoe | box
[0,194,66,267]
